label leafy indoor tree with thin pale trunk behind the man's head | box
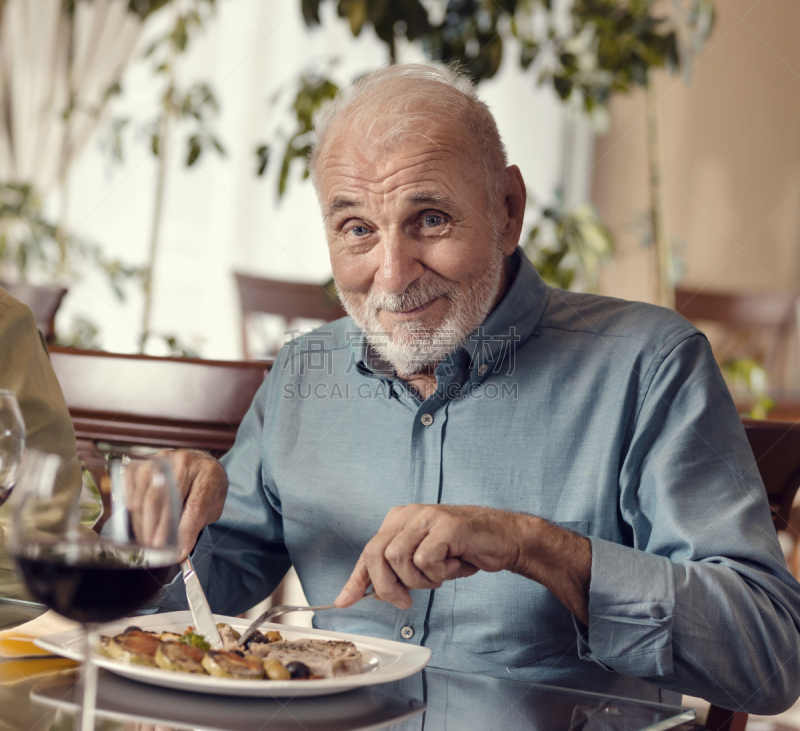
[256,0,714,306]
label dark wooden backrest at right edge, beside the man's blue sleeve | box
[742,419,800,530]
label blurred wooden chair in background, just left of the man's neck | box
[233,272,346,359]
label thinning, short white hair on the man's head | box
[309,64,508,207]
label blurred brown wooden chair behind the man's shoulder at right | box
[675,289,798,386]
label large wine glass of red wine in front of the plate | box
[10,450,181,731]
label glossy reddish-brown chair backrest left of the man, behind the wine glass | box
[50,347,271,484]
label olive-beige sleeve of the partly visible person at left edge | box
[0,289,81,598]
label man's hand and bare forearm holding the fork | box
[336,505,592,623]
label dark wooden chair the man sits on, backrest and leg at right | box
[706,419,800,731]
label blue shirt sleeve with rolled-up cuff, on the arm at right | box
[576,335,800,713]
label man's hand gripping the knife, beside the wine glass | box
[156,449,228,561]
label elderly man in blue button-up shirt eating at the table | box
[164,66,800,712]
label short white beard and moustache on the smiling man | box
[336,249,503,376]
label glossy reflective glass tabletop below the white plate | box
[21,669,694,731]
